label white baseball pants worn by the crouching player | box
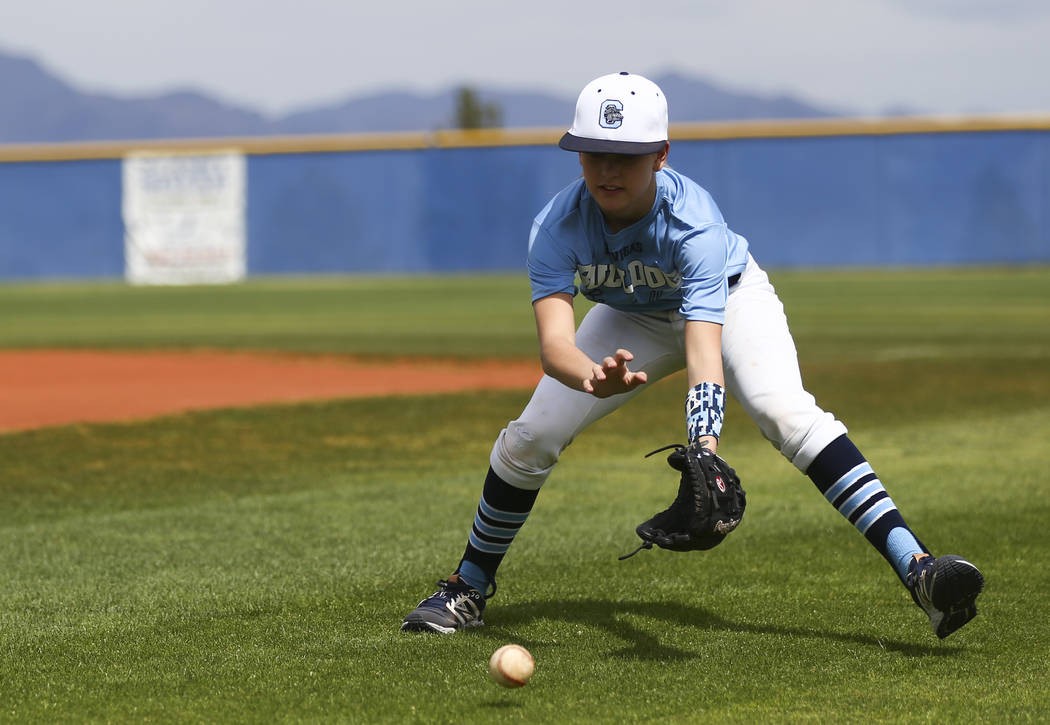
[489,256,846,491]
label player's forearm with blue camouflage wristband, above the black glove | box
[686,319,726,451]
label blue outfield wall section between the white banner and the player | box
[248,146,576,274]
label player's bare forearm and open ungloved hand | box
[532,293,646,398]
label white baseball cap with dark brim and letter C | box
[558,71,667,156]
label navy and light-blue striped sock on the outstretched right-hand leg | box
[805,435,928,582]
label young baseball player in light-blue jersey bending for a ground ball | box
[401,73,984,638]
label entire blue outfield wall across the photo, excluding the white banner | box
[0,122,1050,279]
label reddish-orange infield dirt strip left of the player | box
[0,350,542,432]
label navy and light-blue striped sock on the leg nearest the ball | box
[457,469,540,593]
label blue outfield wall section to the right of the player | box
[672,132,1050,266]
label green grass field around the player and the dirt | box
[0,268,1050,723]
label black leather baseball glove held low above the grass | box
[620,443,747,560]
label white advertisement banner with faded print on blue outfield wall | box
[123,151,247,285]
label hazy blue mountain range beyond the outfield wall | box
[0,51,851,144]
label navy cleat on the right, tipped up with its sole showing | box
[905,554,984,639]
